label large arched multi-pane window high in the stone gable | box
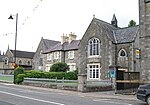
[88,38,100,56]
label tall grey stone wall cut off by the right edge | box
[139,0,150,82]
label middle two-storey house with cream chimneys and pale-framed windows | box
[44,33,80,71]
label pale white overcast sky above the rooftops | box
[0,0,139,53]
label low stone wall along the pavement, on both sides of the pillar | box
[22,78,112,92]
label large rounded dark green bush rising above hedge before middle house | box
[50,62,68,72]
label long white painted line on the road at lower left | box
[0,91,65,105]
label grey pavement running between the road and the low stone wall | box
[0,83,137,101]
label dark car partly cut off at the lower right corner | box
[136,84,150,105]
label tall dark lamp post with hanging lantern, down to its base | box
[8,13,18,84]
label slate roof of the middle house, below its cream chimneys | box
[44,40,80,54]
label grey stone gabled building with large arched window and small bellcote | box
[78,15,139,91]
